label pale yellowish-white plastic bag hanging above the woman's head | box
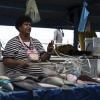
[25,0,40,23]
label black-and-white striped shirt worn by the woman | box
[3,37,45,74]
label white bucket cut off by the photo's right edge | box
[93,37,100,56]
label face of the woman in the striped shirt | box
[19,22,31,35]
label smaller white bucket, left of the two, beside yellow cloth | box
[84,38,93,51]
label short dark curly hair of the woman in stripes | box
[15,16,32,31]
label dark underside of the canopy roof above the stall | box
[0,0,100,31]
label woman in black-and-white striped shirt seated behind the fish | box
[3,16,51,75]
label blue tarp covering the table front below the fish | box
[0,85,100,100]
